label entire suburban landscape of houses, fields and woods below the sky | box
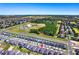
[0,15,79,55]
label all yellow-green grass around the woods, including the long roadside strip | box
[5,22,67,44]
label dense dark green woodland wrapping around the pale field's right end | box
[31,18,57,36]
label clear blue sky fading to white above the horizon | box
[0,3,79,15]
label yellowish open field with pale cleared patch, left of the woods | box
[7,23,45,33]
